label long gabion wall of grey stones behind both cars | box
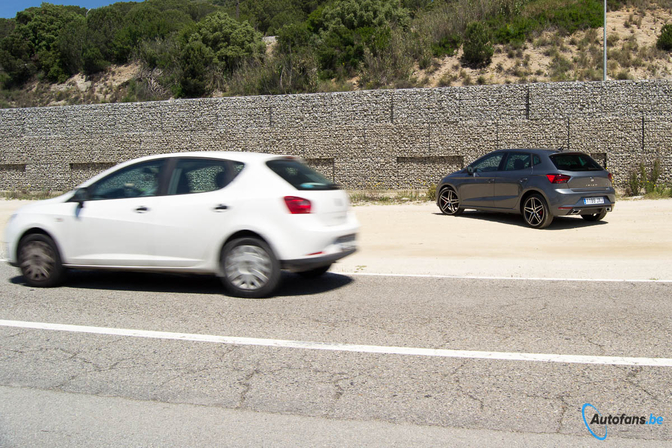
[0,81,672,190]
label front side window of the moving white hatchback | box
[88,159,165,201]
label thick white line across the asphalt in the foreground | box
[0,320,672,367]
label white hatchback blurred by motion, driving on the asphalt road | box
[5,152,359,297]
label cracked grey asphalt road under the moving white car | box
[0,266,672,446]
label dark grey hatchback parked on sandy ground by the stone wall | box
[436,149,616,229]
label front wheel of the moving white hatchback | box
[18,234,65,287]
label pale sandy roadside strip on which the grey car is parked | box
[0,199,672,280]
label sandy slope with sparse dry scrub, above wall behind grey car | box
[413,8,672,87]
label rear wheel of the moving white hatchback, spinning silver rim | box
[222,238,280,298]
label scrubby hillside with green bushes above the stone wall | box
[0,0,672,107]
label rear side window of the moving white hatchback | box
[168,158,242,195]
